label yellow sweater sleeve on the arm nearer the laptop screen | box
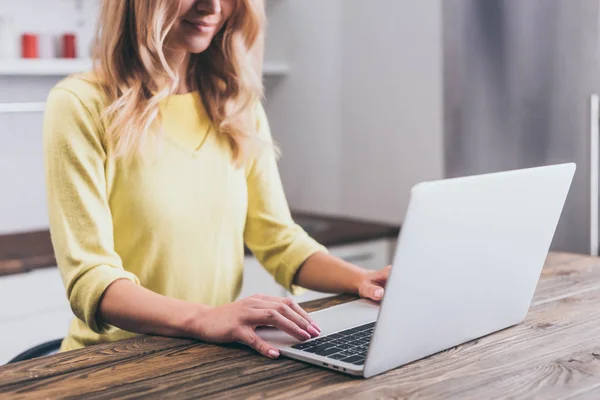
[244,105,327,294]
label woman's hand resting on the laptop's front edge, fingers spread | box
[195,294,321,358]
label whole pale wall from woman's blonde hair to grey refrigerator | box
[267,0,443,223]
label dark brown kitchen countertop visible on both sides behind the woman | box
[0,212,399,276]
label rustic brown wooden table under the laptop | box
[0,253,600,399]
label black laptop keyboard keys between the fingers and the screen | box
[292,322,375,365]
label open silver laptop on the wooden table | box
[257,163,575,378]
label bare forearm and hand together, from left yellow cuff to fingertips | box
[96,279,320,358]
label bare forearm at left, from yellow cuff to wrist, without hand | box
[96,279,208,338]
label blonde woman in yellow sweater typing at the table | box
[44,0,389,358]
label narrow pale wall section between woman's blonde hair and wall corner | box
[265,0,345,213]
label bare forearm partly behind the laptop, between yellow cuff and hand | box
[294,252,366,294]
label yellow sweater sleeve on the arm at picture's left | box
[43,87,139,333]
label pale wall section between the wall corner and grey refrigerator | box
[340,0,443,223]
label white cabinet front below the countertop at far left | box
[0,268,74,365]
